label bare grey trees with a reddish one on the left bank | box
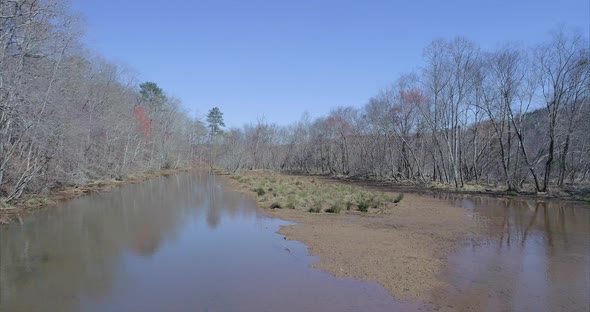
[0,0,208,203]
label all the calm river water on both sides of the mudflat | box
[0,172,590,312]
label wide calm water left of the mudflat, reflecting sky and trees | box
[0,173,411,312]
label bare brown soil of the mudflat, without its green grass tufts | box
[223,172,476,300]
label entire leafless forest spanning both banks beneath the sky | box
[0,0,590,207]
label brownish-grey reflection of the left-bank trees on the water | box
[0,174,253,311]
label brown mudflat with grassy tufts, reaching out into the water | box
[222,171,477,300]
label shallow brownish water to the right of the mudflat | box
[432,196,590,311]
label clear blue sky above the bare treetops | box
[72,0,590,126]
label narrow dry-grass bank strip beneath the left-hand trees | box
[0,167,196,225]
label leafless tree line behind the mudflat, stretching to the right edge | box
[214,28,590,192]
